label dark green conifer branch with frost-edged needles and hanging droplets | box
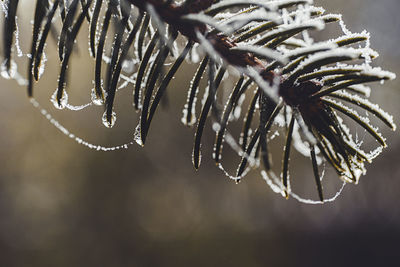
[2,0,396,202]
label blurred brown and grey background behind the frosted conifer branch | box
[0,0,400,266]
